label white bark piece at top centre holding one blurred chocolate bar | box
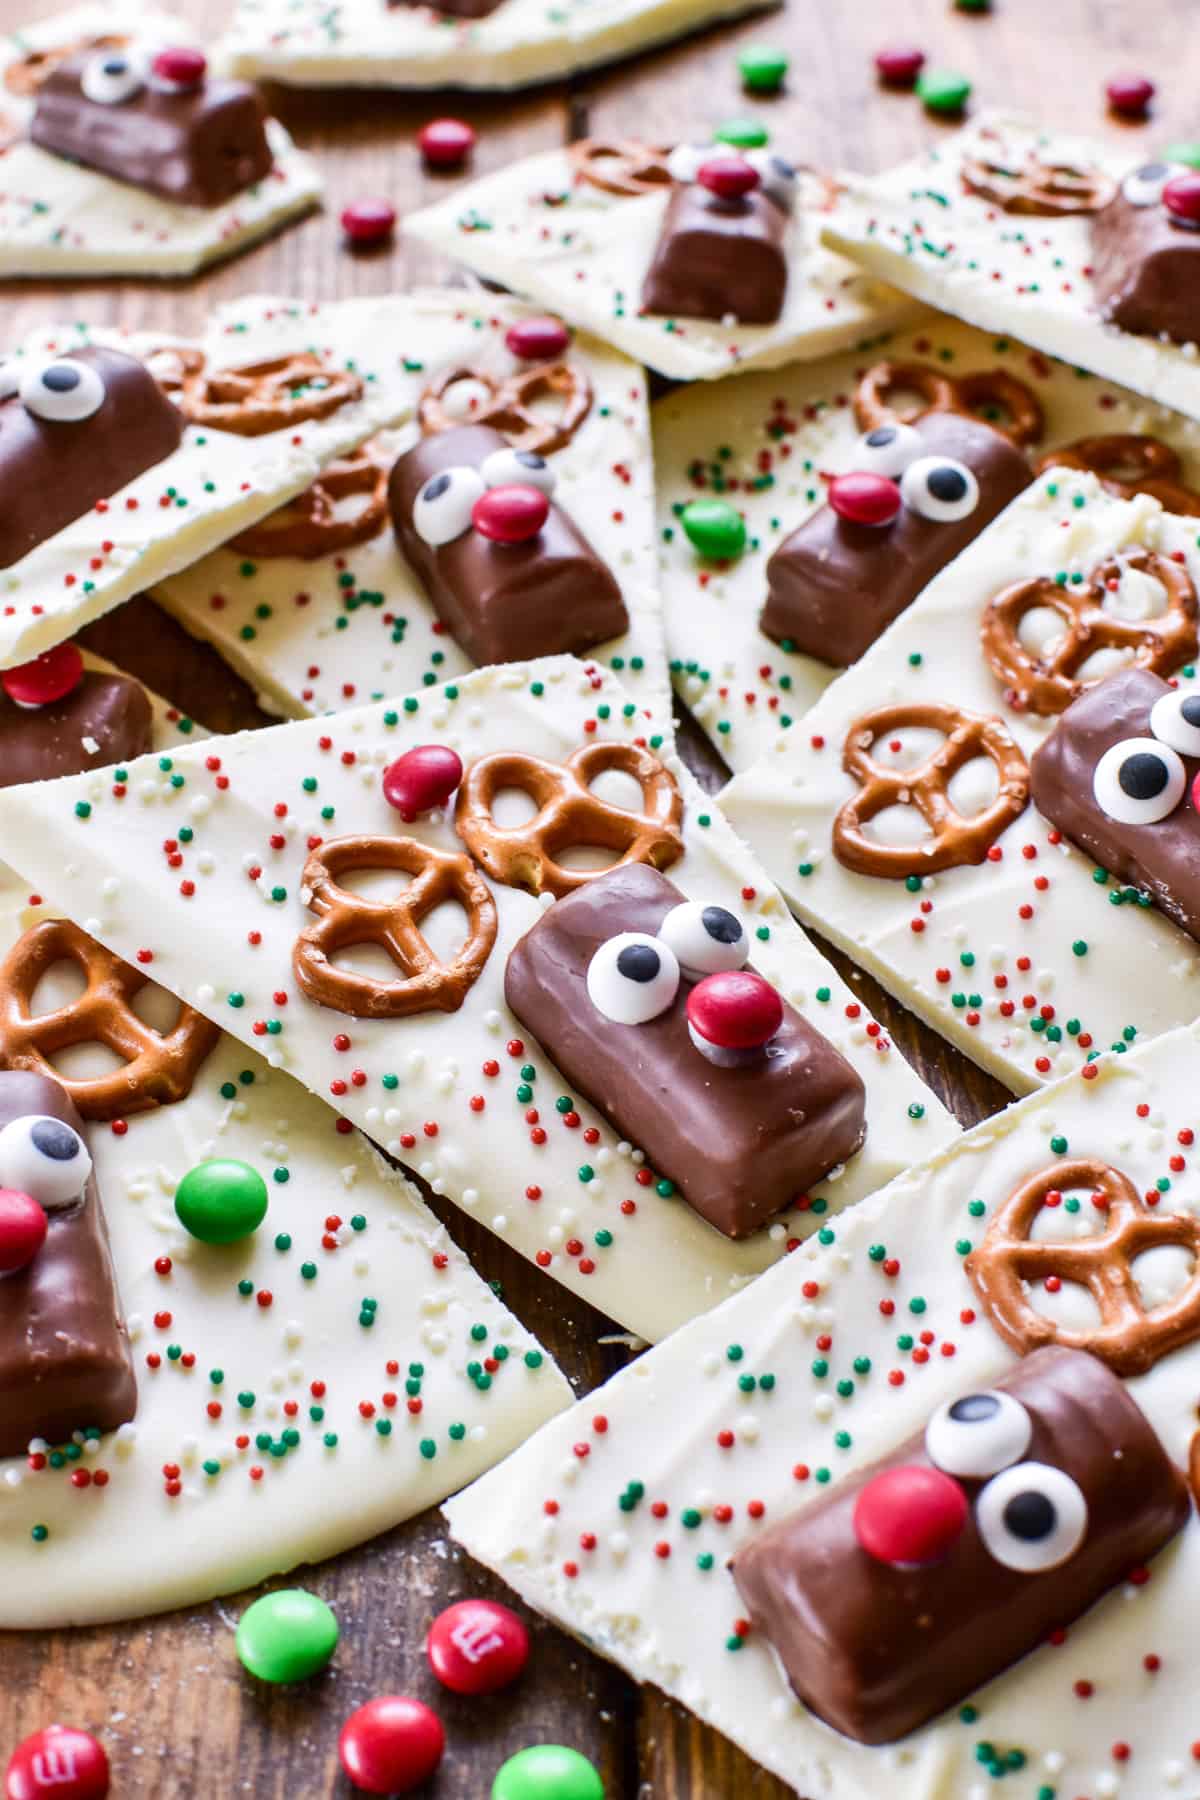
[405,146,912,382]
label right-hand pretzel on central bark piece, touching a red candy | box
[453,743,684,896]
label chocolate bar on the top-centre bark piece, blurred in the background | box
[642,182,792,326]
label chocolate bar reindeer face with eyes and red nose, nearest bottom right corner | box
[732,1348,1191,1744]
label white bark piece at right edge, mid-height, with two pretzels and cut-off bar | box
[723,470,1200,1093]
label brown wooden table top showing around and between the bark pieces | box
[0,0,1200,1800]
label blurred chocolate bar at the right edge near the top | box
[1092,193,1200,344]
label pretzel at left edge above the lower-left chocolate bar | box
[0,918,221,1120]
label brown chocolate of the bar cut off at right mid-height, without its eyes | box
[1029,670,1200,940]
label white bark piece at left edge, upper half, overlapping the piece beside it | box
[0,295,438,668]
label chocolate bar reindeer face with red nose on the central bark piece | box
[504,864,865,1238]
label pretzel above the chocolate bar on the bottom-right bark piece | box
[966,1157,1200,1375]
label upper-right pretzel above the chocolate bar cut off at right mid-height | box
[981,551,1196,718]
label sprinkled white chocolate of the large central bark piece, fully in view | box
[0,657,955,1337]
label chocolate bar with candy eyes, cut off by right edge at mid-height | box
[1029,670,1200,940]
